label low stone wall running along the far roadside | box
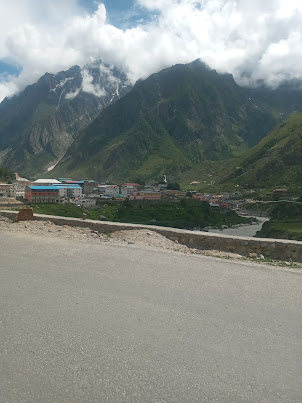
[0,210,302,262]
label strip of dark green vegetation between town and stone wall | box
[32,199,251,229]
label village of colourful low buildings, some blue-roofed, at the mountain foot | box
[0,173,237,209]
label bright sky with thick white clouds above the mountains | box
[0,0,302,101]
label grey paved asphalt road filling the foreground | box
[0,232,302,403]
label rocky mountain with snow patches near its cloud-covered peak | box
[0,61,130,176]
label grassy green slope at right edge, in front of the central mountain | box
[222,113,302,188]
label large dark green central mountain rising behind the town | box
[54,60,302,181]
